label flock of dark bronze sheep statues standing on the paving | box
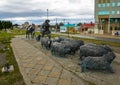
[36,37,116,73]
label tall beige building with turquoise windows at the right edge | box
[94,0,120,35]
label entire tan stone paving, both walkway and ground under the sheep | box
[11,37,120,85]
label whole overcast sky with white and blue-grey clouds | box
[0,0,94,24]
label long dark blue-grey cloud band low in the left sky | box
[0,10,64,18]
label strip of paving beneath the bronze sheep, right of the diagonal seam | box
[27,40,120,85]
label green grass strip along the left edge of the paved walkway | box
[0,31,25,85]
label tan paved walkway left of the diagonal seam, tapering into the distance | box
[11,37,90,85]
